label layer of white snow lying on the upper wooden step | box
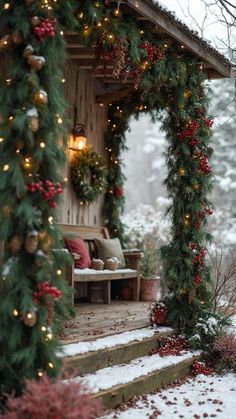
[60,327,172,356]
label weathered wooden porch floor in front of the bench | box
[59,300,150,343]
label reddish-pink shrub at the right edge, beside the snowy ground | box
[213,333,236,369]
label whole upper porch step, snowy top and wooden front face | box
[63,327,173,374]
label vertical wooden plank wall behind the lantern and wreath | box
[59,65,107,226]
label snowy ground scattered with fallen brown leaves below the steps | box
[102,373,236,419]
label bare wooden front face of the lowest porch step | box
[93,356,201,410]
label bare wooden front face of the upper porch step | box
[63,331,174,376]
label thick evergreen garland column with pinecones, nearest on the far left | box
[0,0,76,394]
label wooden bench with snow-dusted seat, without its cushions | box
[59,224,142,304]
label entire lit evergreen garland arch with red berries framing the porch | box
[0,0,216,392]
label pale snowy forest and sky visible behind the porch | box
[123,0,236,246]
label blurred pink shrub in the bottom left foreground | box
[0,375,101,419]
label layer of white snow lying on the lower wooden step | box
[72,351,200,393]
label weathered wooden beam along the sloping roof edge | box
[126,0,231,77]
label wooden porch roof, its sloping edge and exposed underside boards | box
[66,0,233,87]
